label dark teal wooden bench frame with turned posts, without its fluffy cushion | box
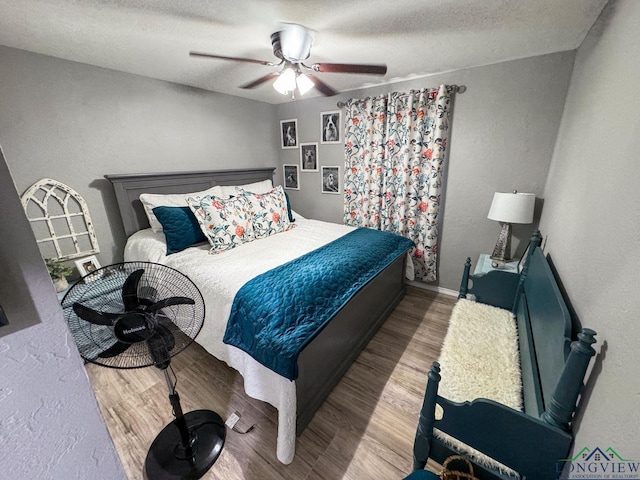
[411,232,596,480]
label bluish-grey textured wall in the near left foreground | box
[0,147,126,480]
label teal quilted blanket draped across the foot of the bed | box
[224,228,413,380]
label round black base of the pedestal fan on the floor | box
[144,410,226,480]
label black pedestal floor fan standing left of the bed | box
[62,262,226,480]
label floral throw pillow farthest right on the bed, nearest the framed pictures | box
[236,185,291,238]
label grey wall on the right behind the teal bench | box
[541,0,640,462]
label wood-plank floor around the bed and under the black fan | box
[87,287,455,480]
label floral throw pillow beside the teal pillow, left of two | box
[187,195,255,253]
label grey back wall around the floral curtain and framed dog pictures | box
[277,52,575,290]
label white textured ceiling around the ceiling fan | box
[0,0,607,103]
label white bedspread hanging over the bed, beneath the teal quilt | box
[124,216,353,464]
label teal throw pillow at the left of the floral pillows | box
[153,207,207,255]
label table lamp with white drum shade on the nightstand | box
[487,190,536,263]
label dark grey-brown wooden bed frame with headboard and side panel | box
[105,168,406,435]
